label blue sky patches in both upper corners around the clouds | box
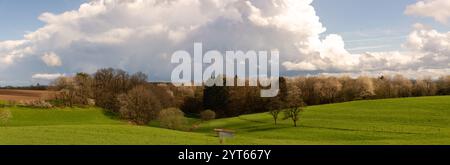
[0,0,449,53]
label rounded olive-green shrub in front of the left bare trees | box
[159,108,187,130]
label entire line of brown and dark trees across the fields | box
[51,68,450,125]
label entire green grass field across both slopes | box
[0,96,450,145]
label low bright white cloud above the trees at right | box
[283,24,450,73]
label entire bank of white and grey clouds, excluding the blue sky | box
[0,0,450,85]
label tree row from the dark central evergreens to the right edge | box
[181,75,450,117]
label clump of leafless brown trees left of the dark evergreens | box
[51,68,183,124]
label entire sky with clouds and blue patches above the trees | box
[0,0,450,86]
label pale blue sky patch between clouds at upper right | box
[313,0,449,53]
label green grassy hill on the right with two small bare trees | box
[197,96,450,144]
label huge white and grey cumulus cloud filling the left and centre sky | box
[0,0,325,79]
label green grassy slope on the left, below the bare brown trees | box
[0,107,217,144]
